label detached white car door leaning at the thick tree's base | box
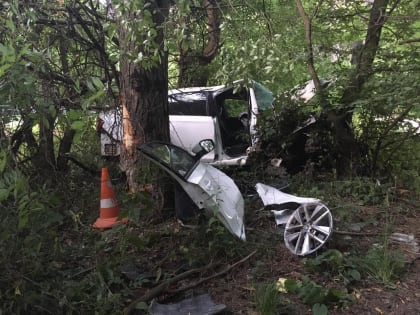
[139,142,245,240]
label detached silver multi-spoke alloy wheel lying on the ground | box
[284,203,333,256]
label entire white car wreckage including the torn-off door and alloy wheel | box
[98,80,333,256]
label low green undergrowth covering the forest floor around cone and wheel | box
[0,147,416,314]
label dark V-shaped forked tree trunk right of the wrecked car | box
[296,0,392,175]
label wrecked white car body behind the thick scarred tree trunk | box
[98,81,274,165]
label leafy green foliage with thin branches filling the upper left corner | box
[0,2,113,175]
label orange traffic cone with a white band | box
[93,167,128,229]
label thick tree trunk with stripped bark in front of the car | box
[120,0,169,193]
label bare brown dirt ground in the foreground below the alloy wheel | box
[129,194,420,315]
